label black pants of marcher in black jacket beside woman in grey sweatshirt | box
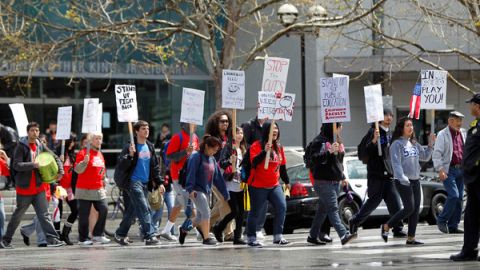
[352,175,403,232]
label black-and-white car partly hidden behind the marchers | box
[264,152,447,234]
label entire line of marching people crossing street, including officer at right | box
[0,94,480,261]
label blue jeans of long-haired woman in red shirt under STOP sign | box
[247,186,287,242]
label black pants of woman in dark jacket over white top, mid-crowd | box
[218,191,244,240]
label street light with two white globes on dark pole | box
[277,4,327,148]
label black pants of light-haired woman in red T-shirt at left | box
[77,199,108,242]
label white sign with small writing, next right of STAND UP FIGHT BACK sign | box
[180,88,205,126]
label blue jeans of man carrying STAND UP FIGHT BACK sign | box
[115,181,154,239]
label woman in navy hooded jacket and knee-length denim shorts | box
[185,134,230,245]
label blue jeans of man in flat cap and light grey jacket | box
[437,167,464,230]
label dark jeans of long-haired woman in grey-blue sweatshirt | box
[387,180,422,237]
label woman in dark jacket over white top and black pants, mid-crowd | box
[213,127,247,245]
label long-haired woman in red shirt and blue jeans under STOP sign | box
[247,123,290,247]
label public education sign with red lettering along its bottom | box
[320,76,350,123]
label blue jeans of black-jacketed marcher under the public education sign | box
[310,180,348,238]
